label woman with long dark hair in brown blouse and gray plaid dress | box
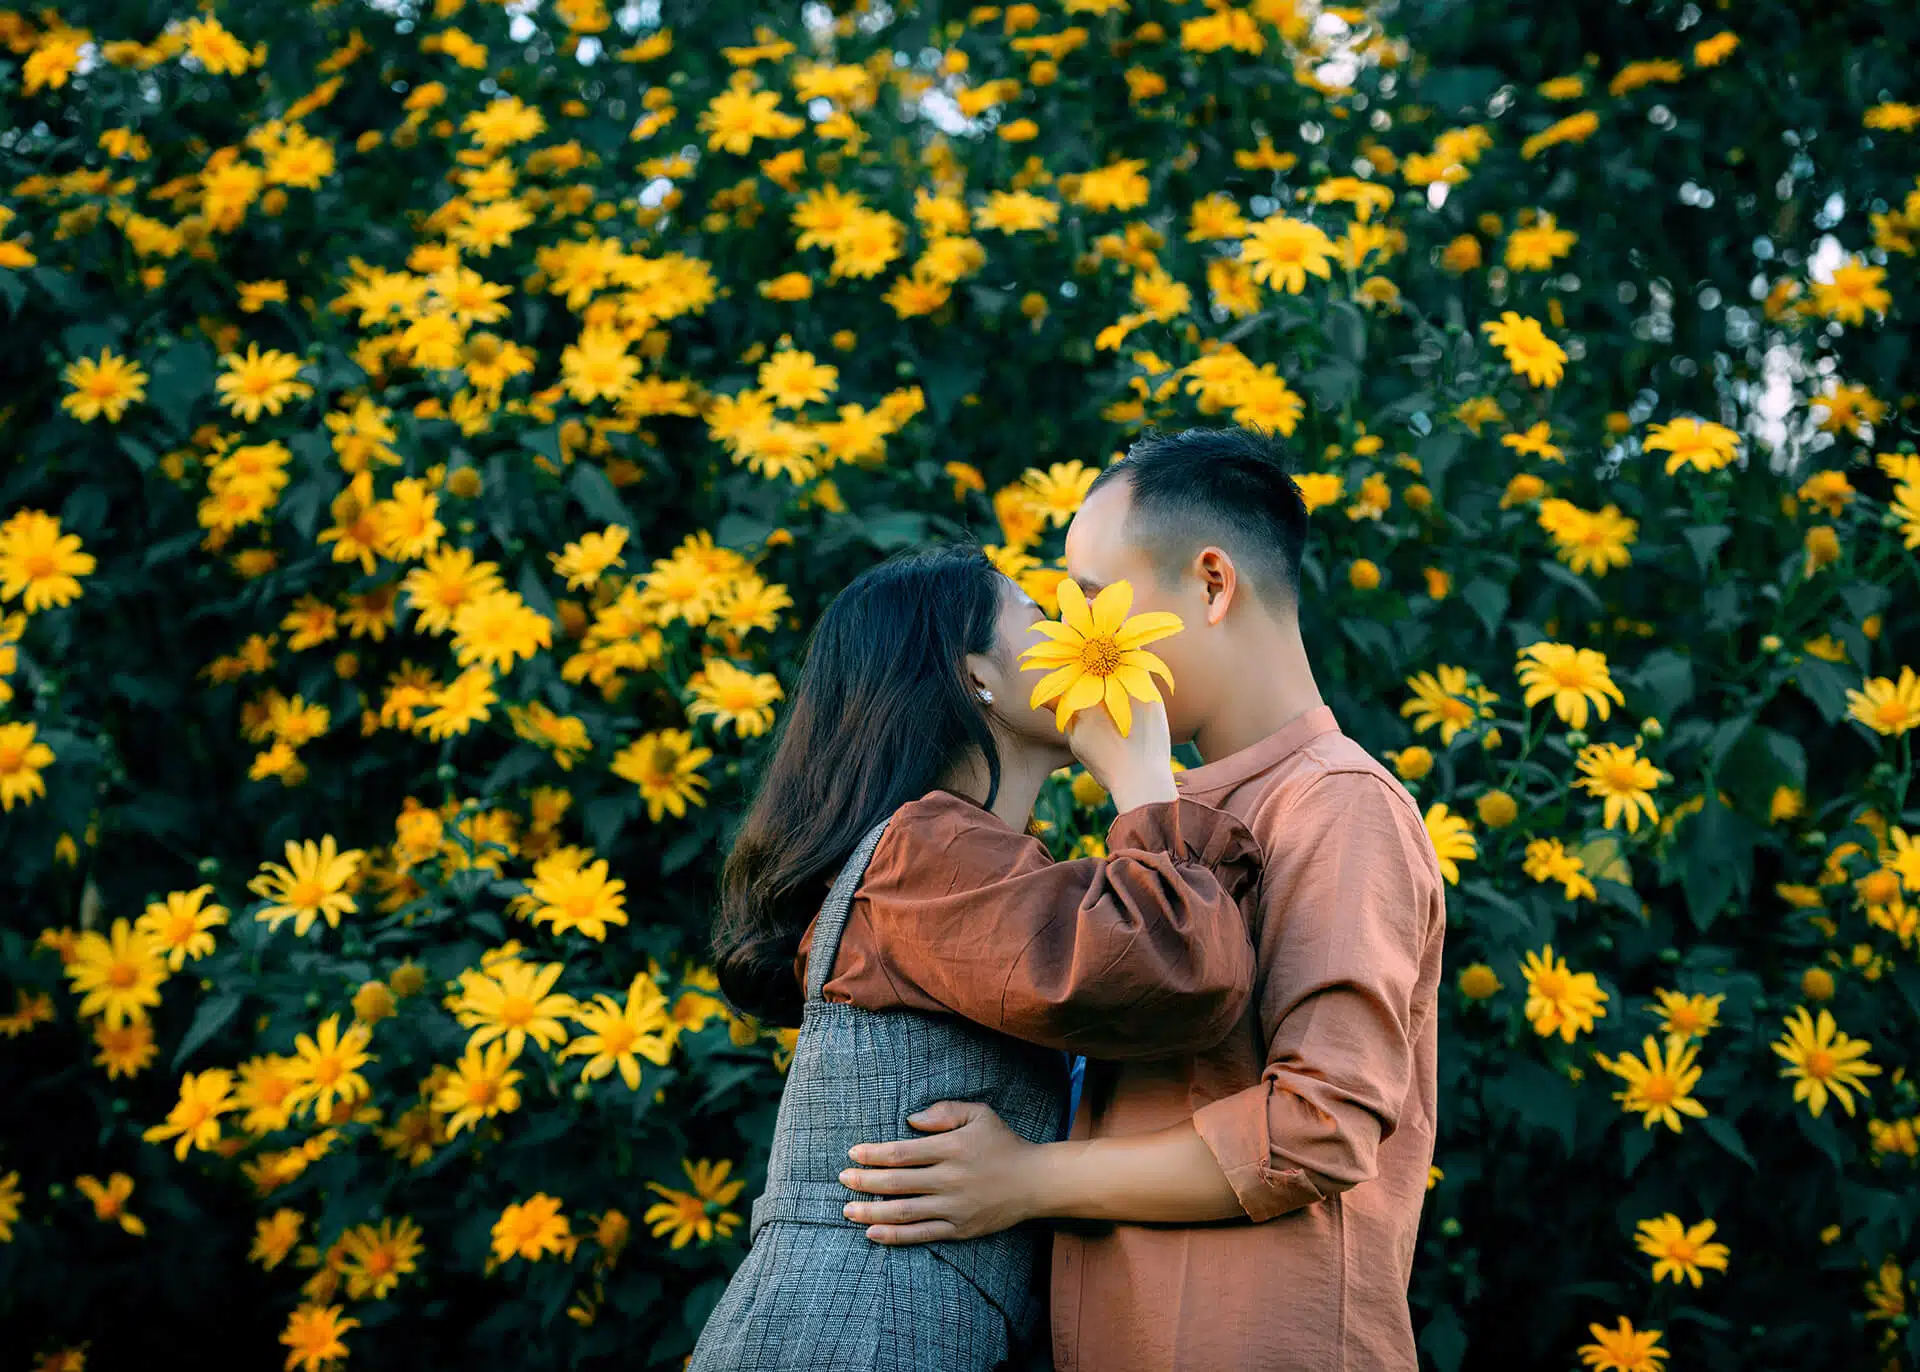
[691,549,1258,1372]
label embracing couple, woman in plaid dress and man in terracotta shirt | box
[691,428,1446,1372]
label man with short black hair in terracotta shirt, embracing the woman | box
[843,430,1446,1372]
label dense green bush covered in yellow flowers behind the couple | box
[0,0,1920,1372]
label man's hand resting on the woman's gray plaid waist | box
[839,1105,1052,1245]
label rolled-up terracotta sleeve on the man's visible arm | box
[1194,771,1440,1220]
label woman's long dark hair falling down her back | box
[714,547,1004,1025]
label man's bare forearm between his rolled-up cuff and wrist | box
[1035,1121,1246,1224]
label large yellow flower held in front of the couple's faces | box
[1020,580,1187,737]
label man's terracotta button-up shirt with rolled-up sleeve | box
[1052,708,1446,1372]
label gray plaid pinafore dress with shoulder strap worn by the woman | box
[689,821,1068,1372]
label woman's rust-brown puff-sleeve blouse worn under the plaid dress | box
[795,791,1260,1059]
